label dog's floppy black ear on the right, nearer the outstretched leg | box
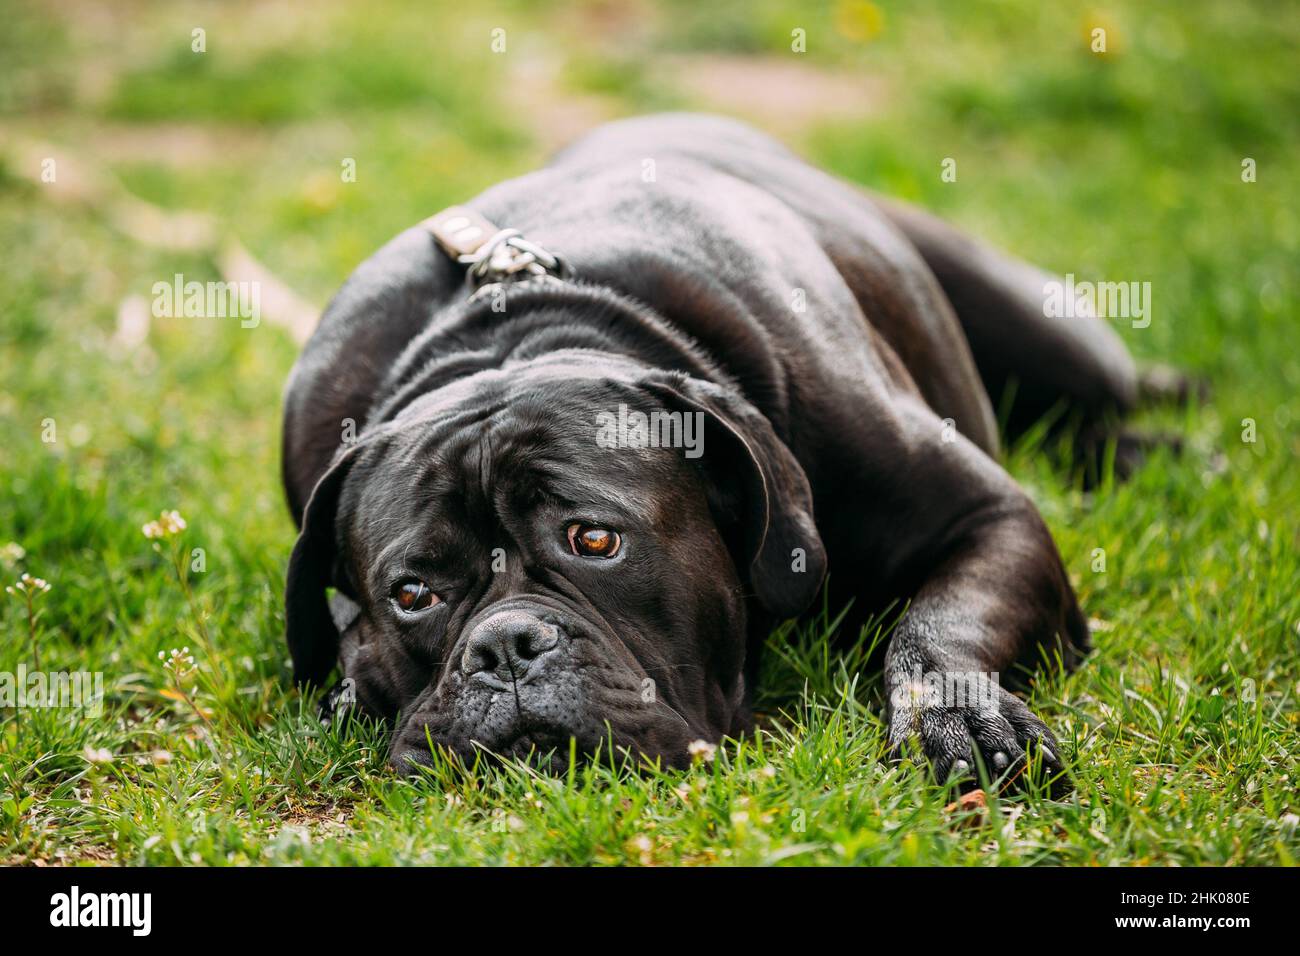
[647,375,826,620]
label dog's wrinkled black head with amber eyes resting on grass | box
[286,352,826,766]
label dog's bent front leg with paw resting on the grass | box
[853,405,1088,779]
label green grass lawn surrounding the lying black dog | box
[0,0,1300,865]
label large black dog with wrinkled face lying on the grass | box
[283,116,1159,775]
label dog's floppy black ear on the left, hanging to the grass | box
[285,446,359,685]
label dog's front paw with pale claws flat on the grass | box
[889,675,1070,795]
